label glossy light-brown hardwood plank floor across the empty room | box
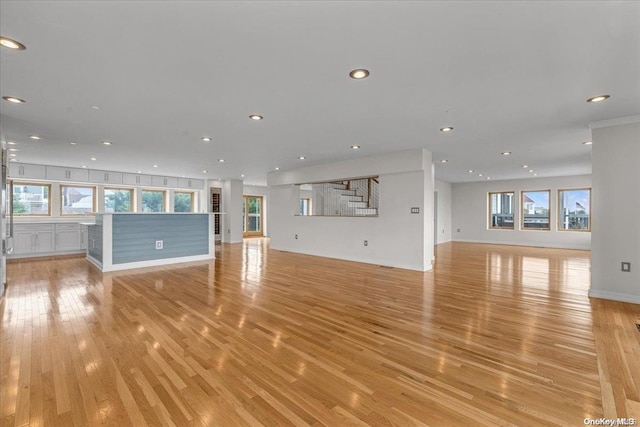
[0,239,640,427]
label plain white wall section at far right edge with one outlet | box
[589,123,640,304]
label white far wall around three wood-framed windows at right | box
[452,175,597,249]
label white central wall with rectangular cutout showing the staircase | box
[268,150,433,271]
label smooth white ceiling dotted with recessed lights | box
[0,1,640,184]
